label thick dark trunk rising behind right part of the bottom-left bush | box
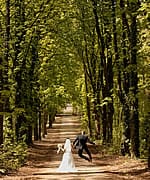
[13,0,27,140]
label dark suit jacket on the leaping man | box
[73,135,95,149]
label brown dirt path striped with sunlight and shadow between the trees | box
[0,116,150,180]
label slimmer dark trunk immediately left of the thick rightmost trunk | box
[117,0,130,155]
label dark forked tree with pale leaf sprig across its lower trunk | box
[92,0,114,142]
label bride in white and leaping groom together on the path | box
[57,131,95,172]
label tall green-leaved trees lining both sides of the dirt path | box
[0,0,150,169]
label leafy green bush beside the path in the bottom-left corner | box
[0,116,27,172]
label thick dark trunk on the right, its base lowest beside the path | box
[129,2,140,157]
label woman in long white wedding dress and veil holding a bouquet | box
[57,138,77,172]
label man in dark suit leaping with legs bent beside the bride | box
[73,131,95,162]
